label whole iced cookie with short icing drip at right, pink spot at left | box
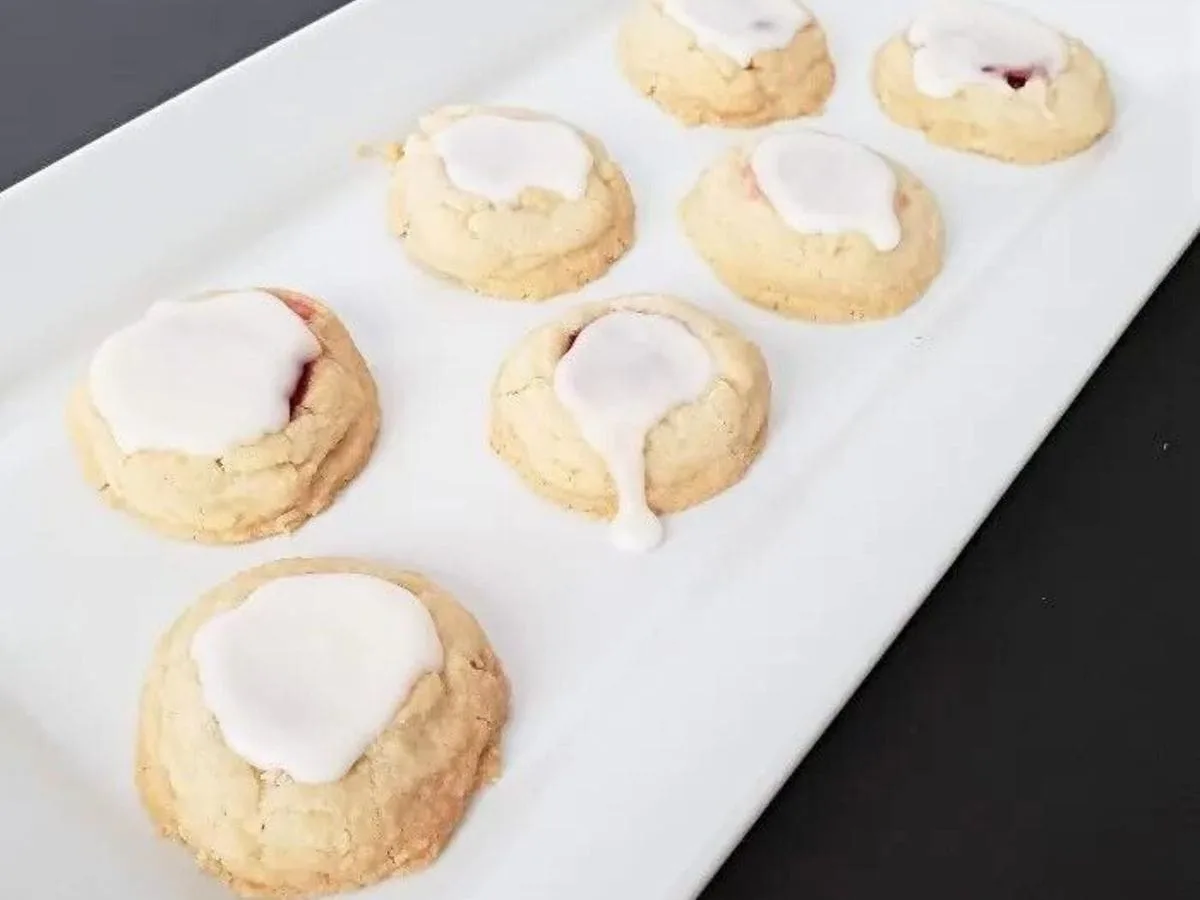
[679,132,943,323]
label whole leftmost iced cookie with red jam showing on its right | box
[67,289,379,544]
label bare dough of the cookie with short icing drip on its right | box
[679,138,943,323]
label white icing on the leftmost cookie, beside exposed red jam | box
[89,290,320,456]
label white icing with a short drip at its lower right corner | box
[750,131,901,252]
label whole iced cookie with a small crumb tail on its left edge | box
[389,107,634,300]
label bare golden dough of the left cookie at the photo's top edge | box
[617,0,835,127]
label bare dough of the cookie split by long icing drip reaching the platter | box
[491,295,770,528]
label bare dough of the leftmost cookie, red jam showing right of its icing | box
[67,289,379,544]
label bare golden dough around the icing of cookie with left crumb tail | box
[389,107,634,300]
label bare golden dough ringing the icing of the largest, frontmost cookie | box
[136,559,509,896]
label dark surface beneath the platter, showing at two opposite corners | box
[0,0,1200,900]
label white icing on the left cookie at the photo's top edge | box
[662,0,812,68]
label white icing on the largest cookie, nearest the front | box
[191,574,443,784]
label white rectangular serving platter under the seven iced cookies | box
[0,0,1200,900]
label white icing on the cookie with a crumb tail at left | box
[433,113,594,204]
